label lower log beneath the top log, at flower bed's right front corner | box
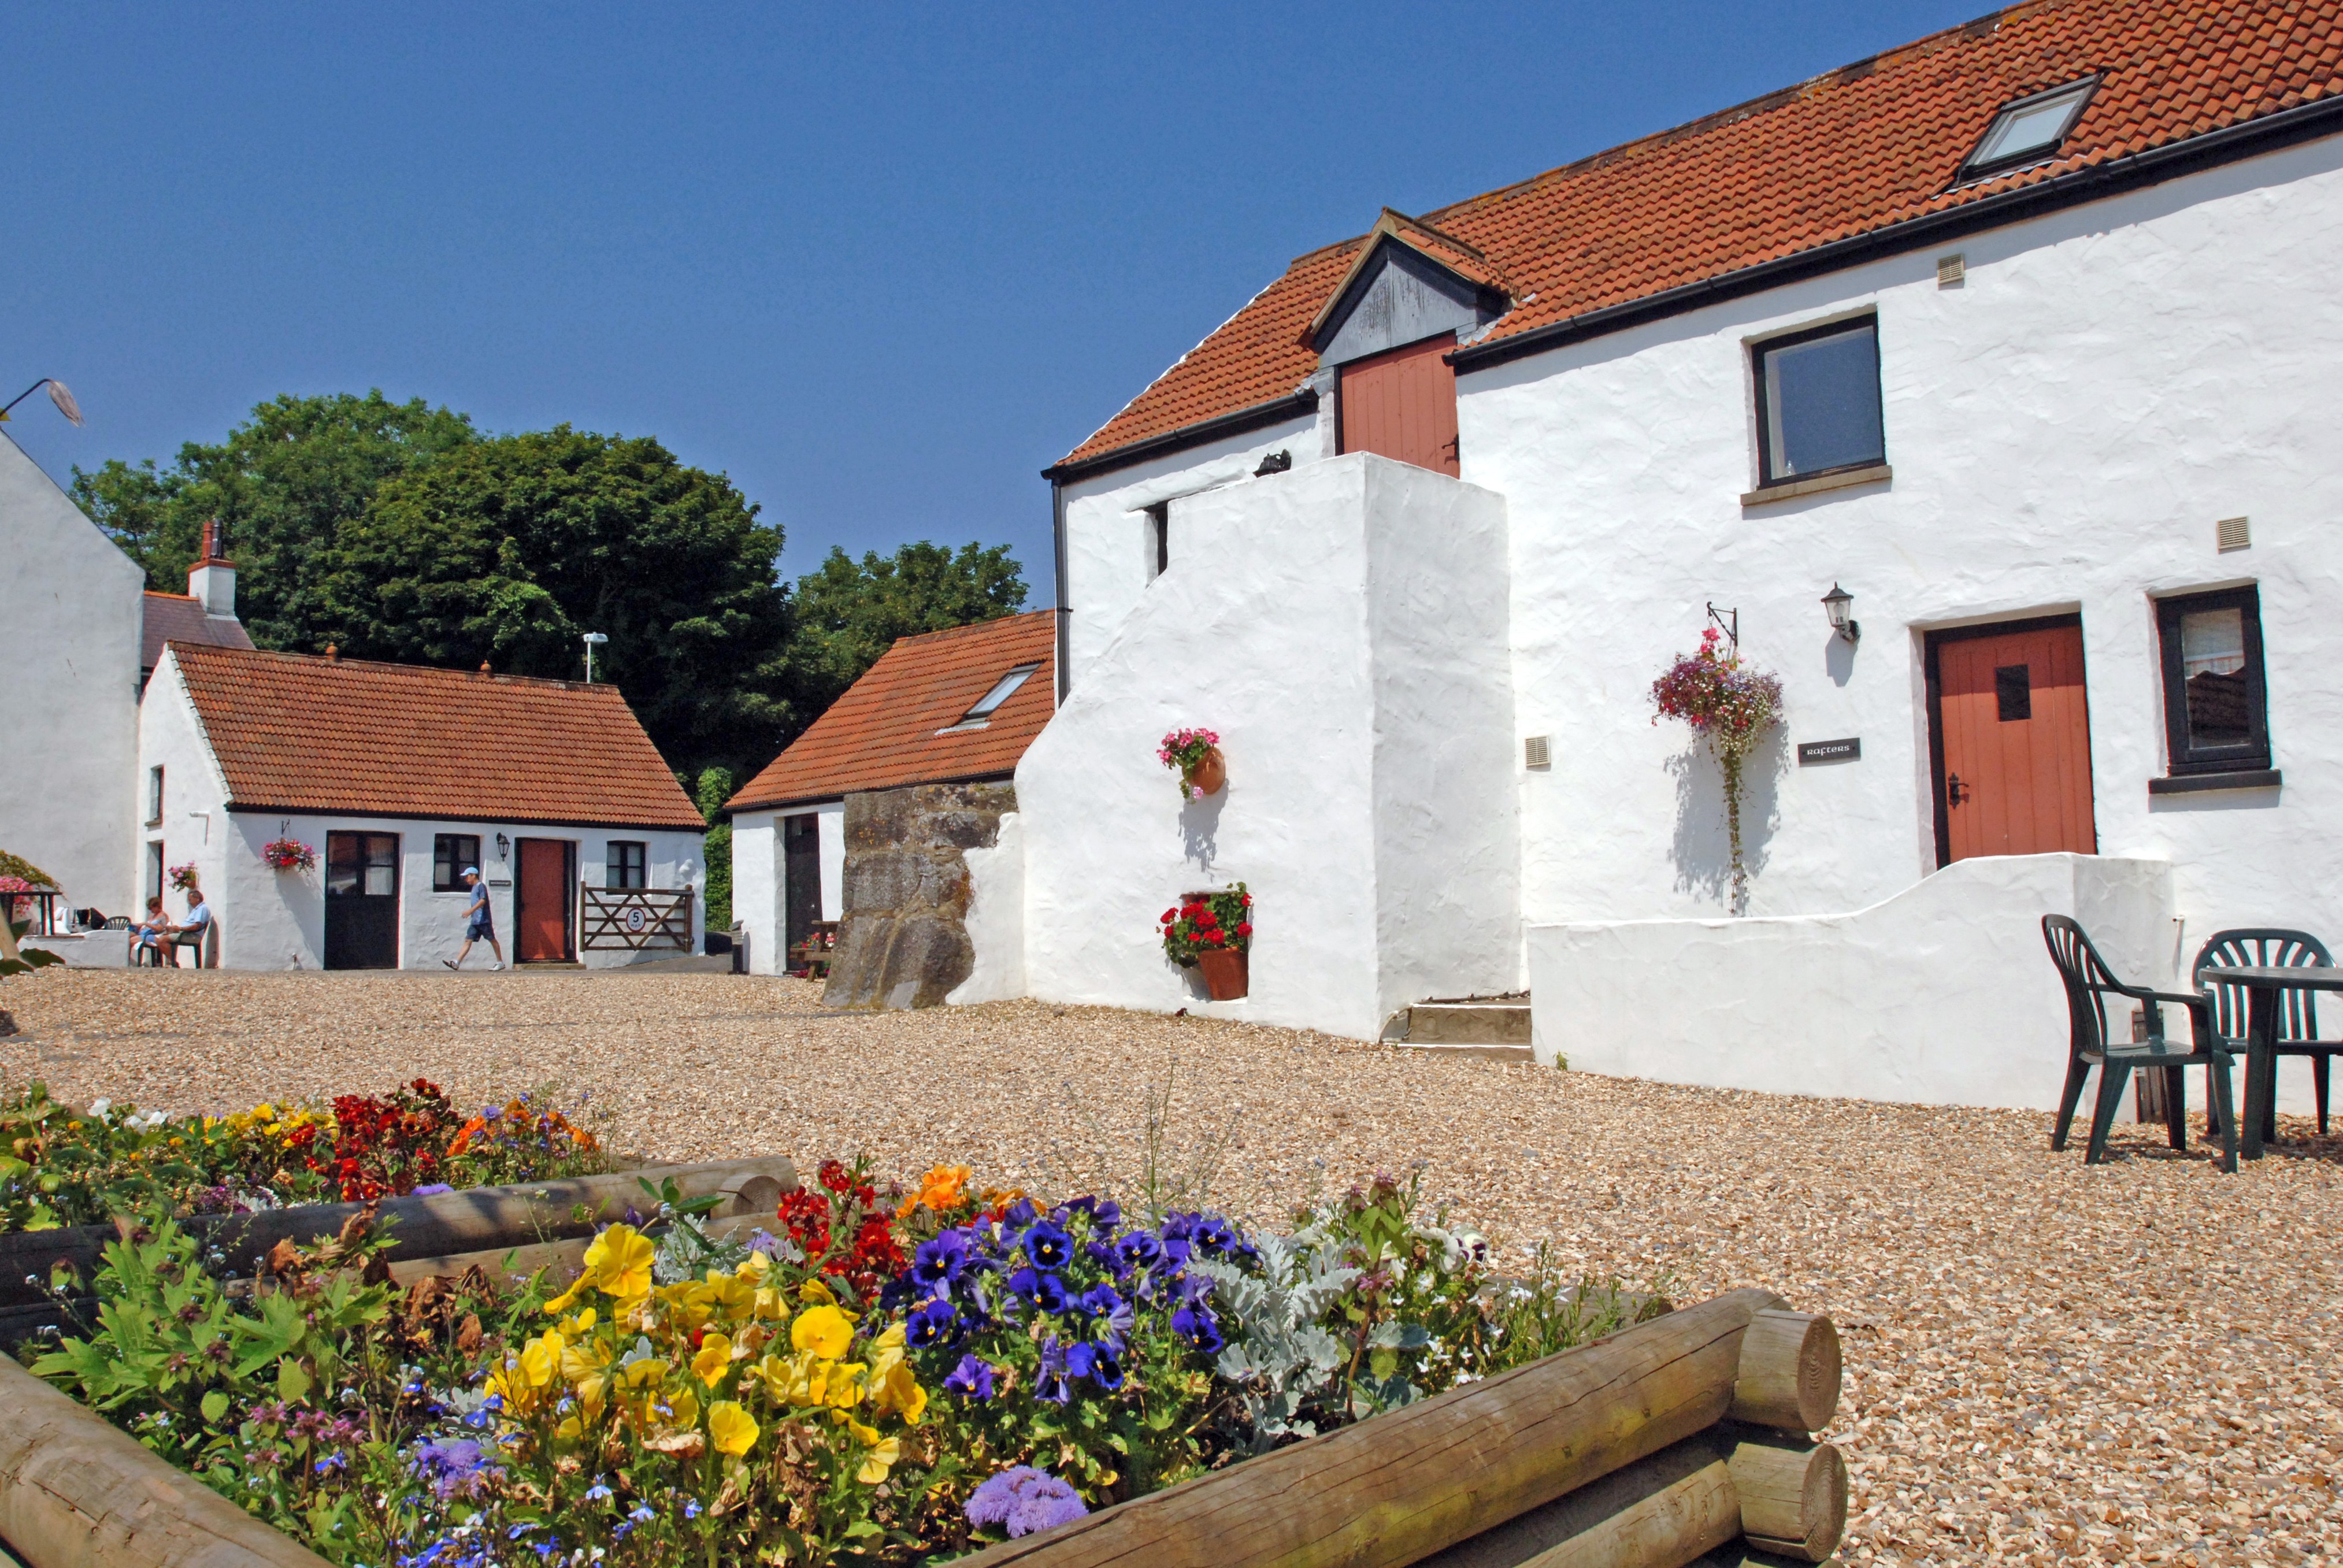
[1420,1428,1741,1568]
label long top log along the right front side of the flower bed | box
[941,1289,1783,1568]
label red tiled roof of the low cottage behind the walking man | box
[171,642,700,830]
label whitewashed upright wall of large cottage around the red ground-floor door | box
[1460,140,2343,956]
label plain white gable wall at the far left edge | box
[0,433,145,914]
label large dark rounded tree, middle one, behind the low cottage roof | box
[316,424,792,771]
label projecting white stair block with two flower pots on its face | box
[1017,455,1521,1036]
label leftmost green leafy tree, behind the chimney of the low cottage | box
[73,391,476,651]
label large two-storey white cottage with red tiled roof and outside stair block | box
[977,0,2343,1104]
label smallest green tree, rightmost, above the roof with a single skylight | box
[789,539,1026,722]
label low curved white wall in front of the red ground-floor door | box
[1530,855,2310,1111]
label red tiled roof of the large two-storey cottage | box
[1061,0,2343,464]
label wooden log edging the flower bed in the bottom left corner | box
[0,1357,326,1568]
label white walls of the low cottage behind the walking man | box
[138,654,707,970]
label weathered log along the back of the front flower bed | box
[0,1155,796,1308]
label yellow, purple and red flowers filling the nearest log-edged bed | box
[9,1143,1748,1568]
